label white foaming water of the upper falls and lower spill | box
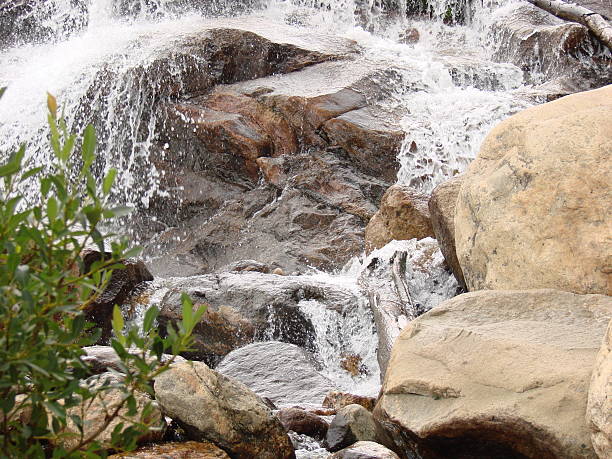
[0,0,604,452]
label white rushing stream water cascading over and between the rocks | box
[0,0,610,457]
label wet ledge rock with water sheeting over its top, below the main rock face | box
[148,272,358,365]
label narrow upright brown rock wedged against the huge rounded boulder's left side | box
[429,177,467,290]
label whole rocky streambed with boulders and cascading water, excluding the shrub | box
[0,0,612,459]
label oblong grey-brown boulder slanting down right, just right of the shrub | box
[155,362,295,459]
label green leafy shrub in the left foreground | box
[0,88,204,458]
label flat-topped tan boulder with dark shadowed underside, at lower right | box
[374,290,612,459]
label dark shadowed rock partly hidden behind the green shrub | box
[82,250,153,344]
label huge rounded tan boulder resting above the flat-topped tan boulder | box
[455,85,612,294]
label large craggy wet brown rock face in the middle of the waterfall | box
[137,35,404,275]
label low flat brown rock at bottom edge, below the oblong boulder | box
[109,441,229,459]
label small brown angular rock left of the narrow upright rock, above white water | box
[365,185,434,251]
